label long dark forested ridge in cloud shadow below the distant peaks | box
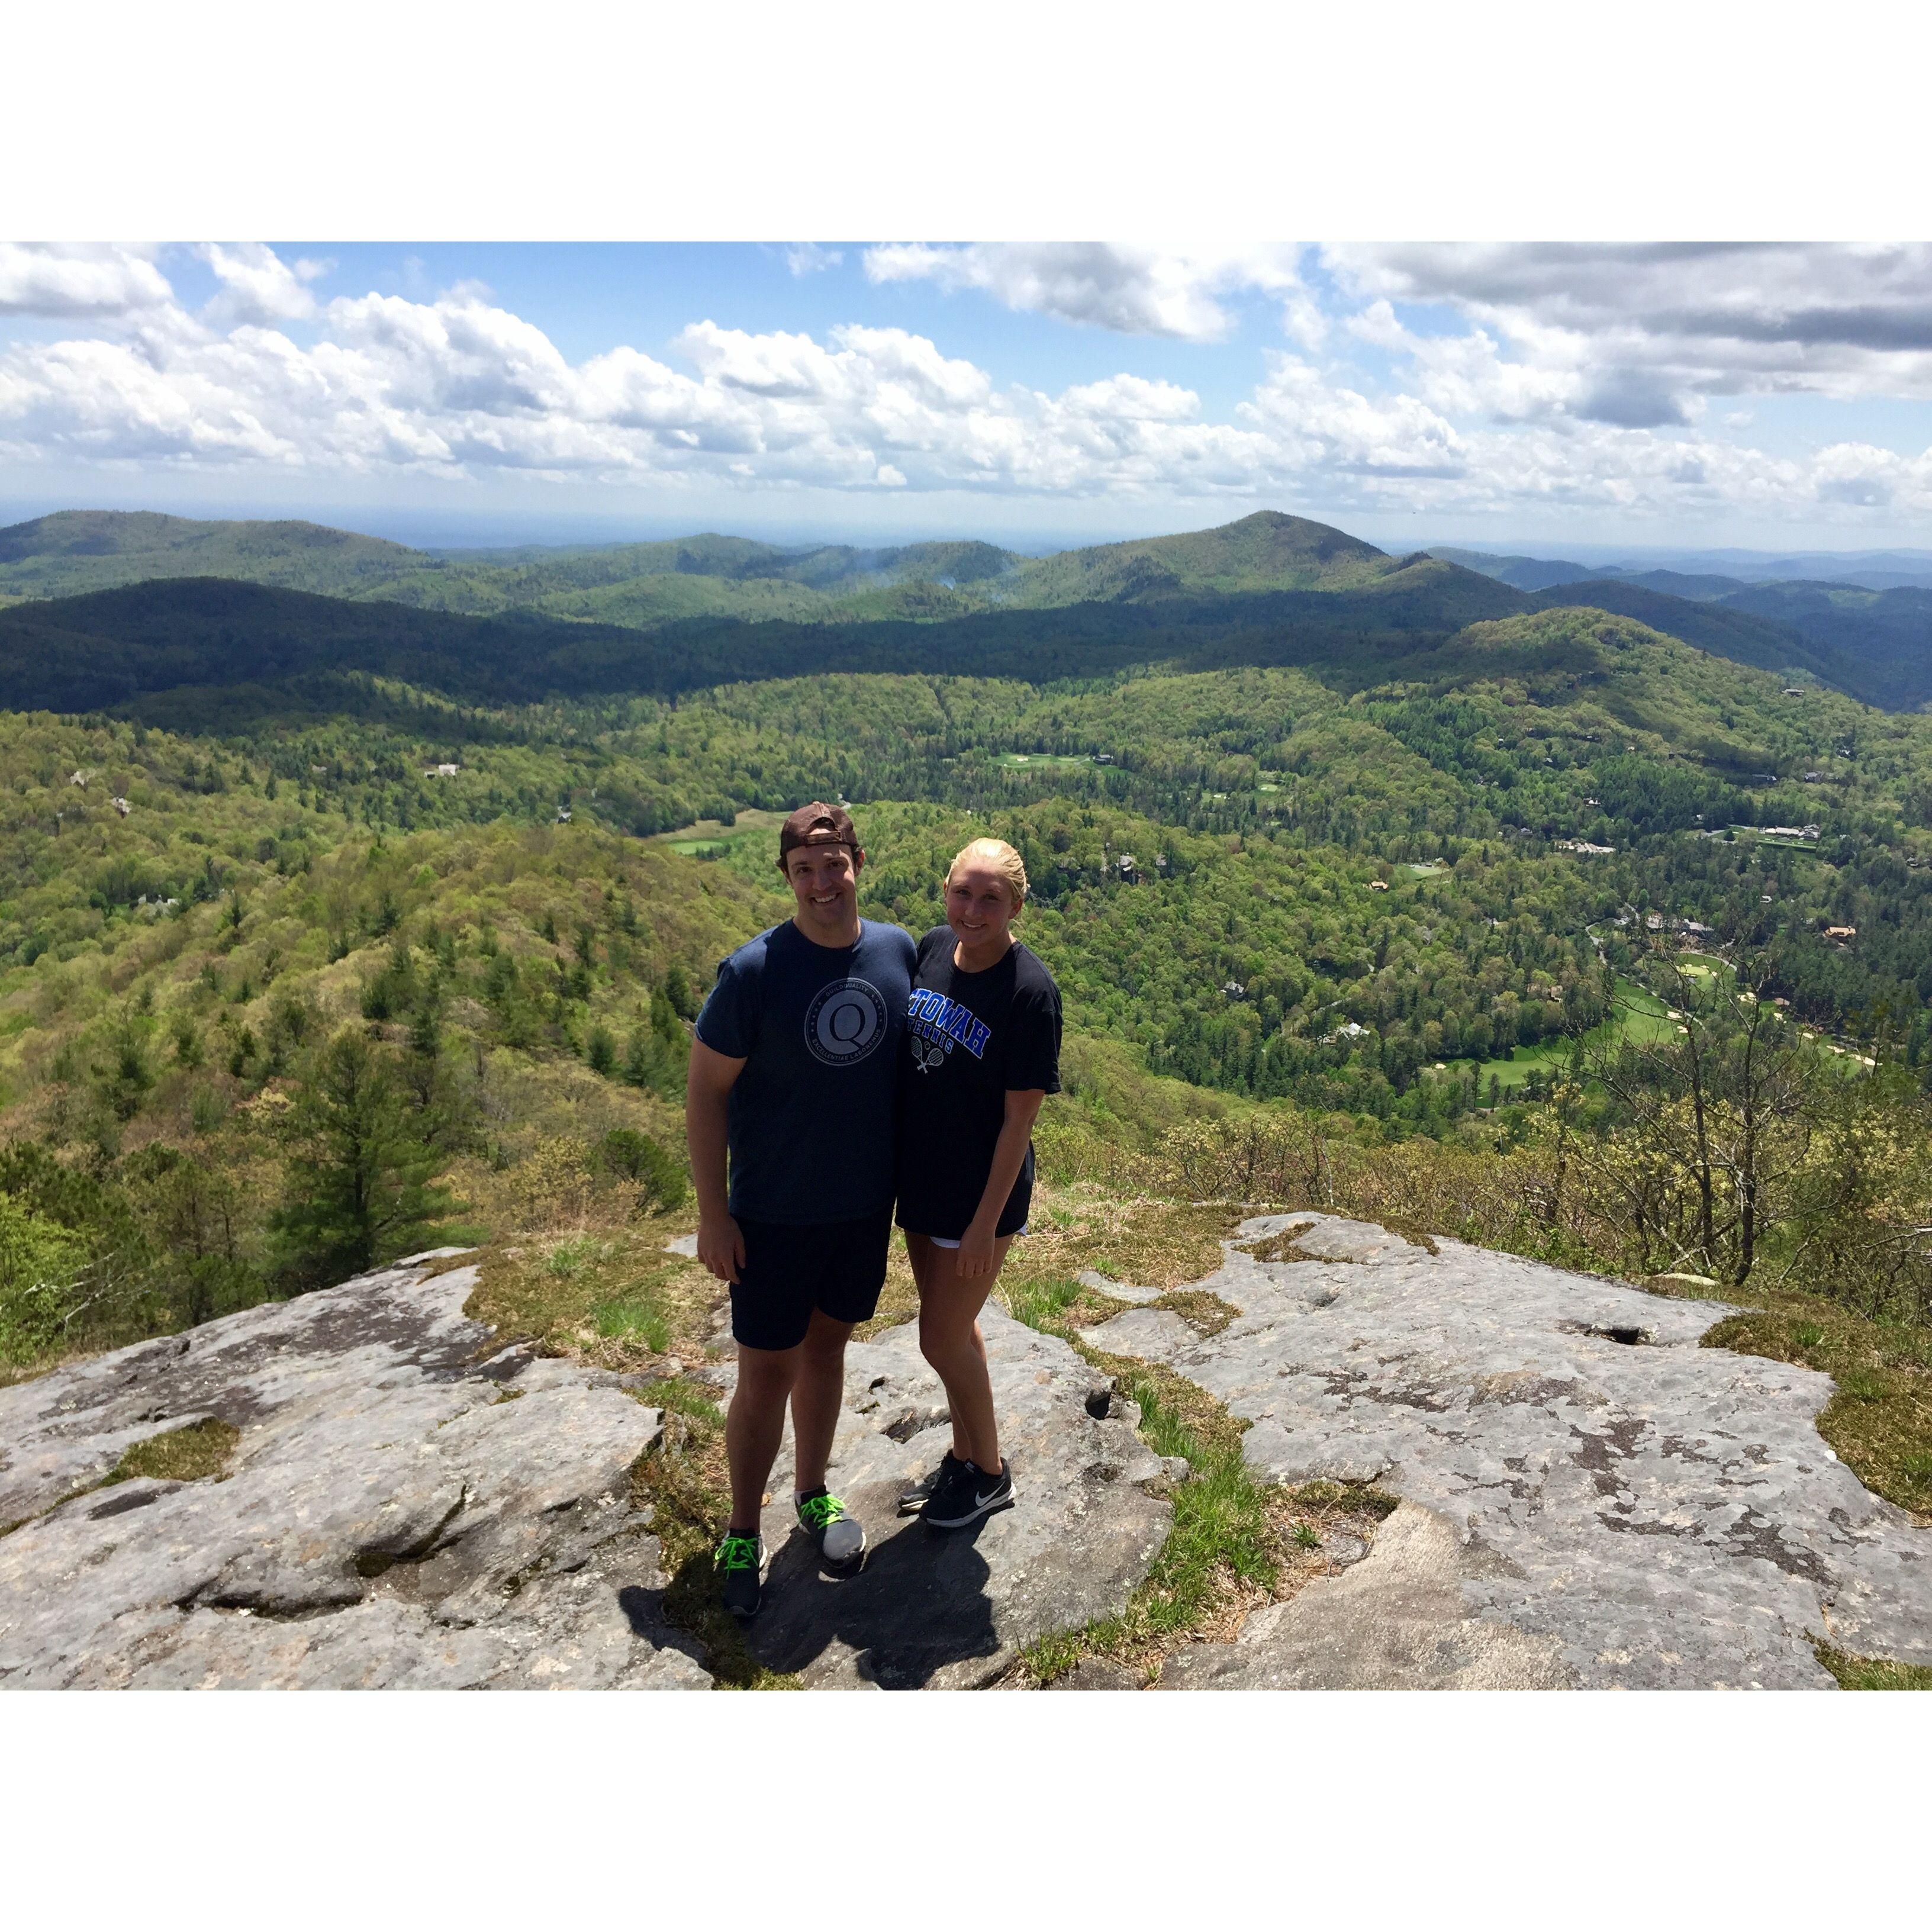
[0,562,1522,711]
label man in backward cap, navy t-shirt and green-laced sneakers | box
[684,802,914,1617]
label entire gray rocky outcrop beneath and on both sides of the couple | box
[18,1215,1932,1689]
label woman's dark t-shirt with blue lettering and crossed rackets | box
[899,925,1061,1240]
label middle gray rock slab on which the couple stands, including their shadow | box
[748,1306,1173,1689]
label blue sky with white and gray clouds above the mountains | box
[0,240,1932,550]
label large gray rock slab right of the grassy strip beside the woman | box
[1091,1215,1932,1689]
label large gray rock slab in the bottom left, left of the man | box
[0,1256,711,1689]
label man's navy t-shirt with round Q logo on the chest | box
[697,920,916,1227]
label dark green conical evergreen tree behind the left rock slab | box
[276,1028,452,1281]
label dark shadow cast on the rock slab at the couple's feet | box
[746,1516,1004,1690]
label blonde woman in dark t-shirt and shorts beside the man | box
[899,839,1061,1530]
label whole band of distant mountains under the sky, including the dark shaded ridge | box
[0,510,1932,709]
